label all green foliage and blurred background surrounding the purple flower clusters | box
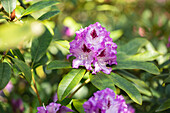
[0,0,170,113]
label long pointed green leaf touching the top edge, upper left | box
[22,0,58,16]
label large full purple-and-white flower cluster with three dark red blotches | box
[67,22,117,74]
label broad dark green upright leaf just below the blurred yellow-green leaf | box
[31,29,52,64]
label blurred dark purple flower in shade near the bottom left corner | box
[11,99,24,113]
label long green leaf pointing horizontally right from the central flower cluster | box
[113,60,160,75]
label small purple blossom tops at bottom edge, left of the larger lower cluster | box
[37,93,73,113]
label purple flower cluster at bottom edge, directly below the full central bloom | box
[83,88,134,113]
